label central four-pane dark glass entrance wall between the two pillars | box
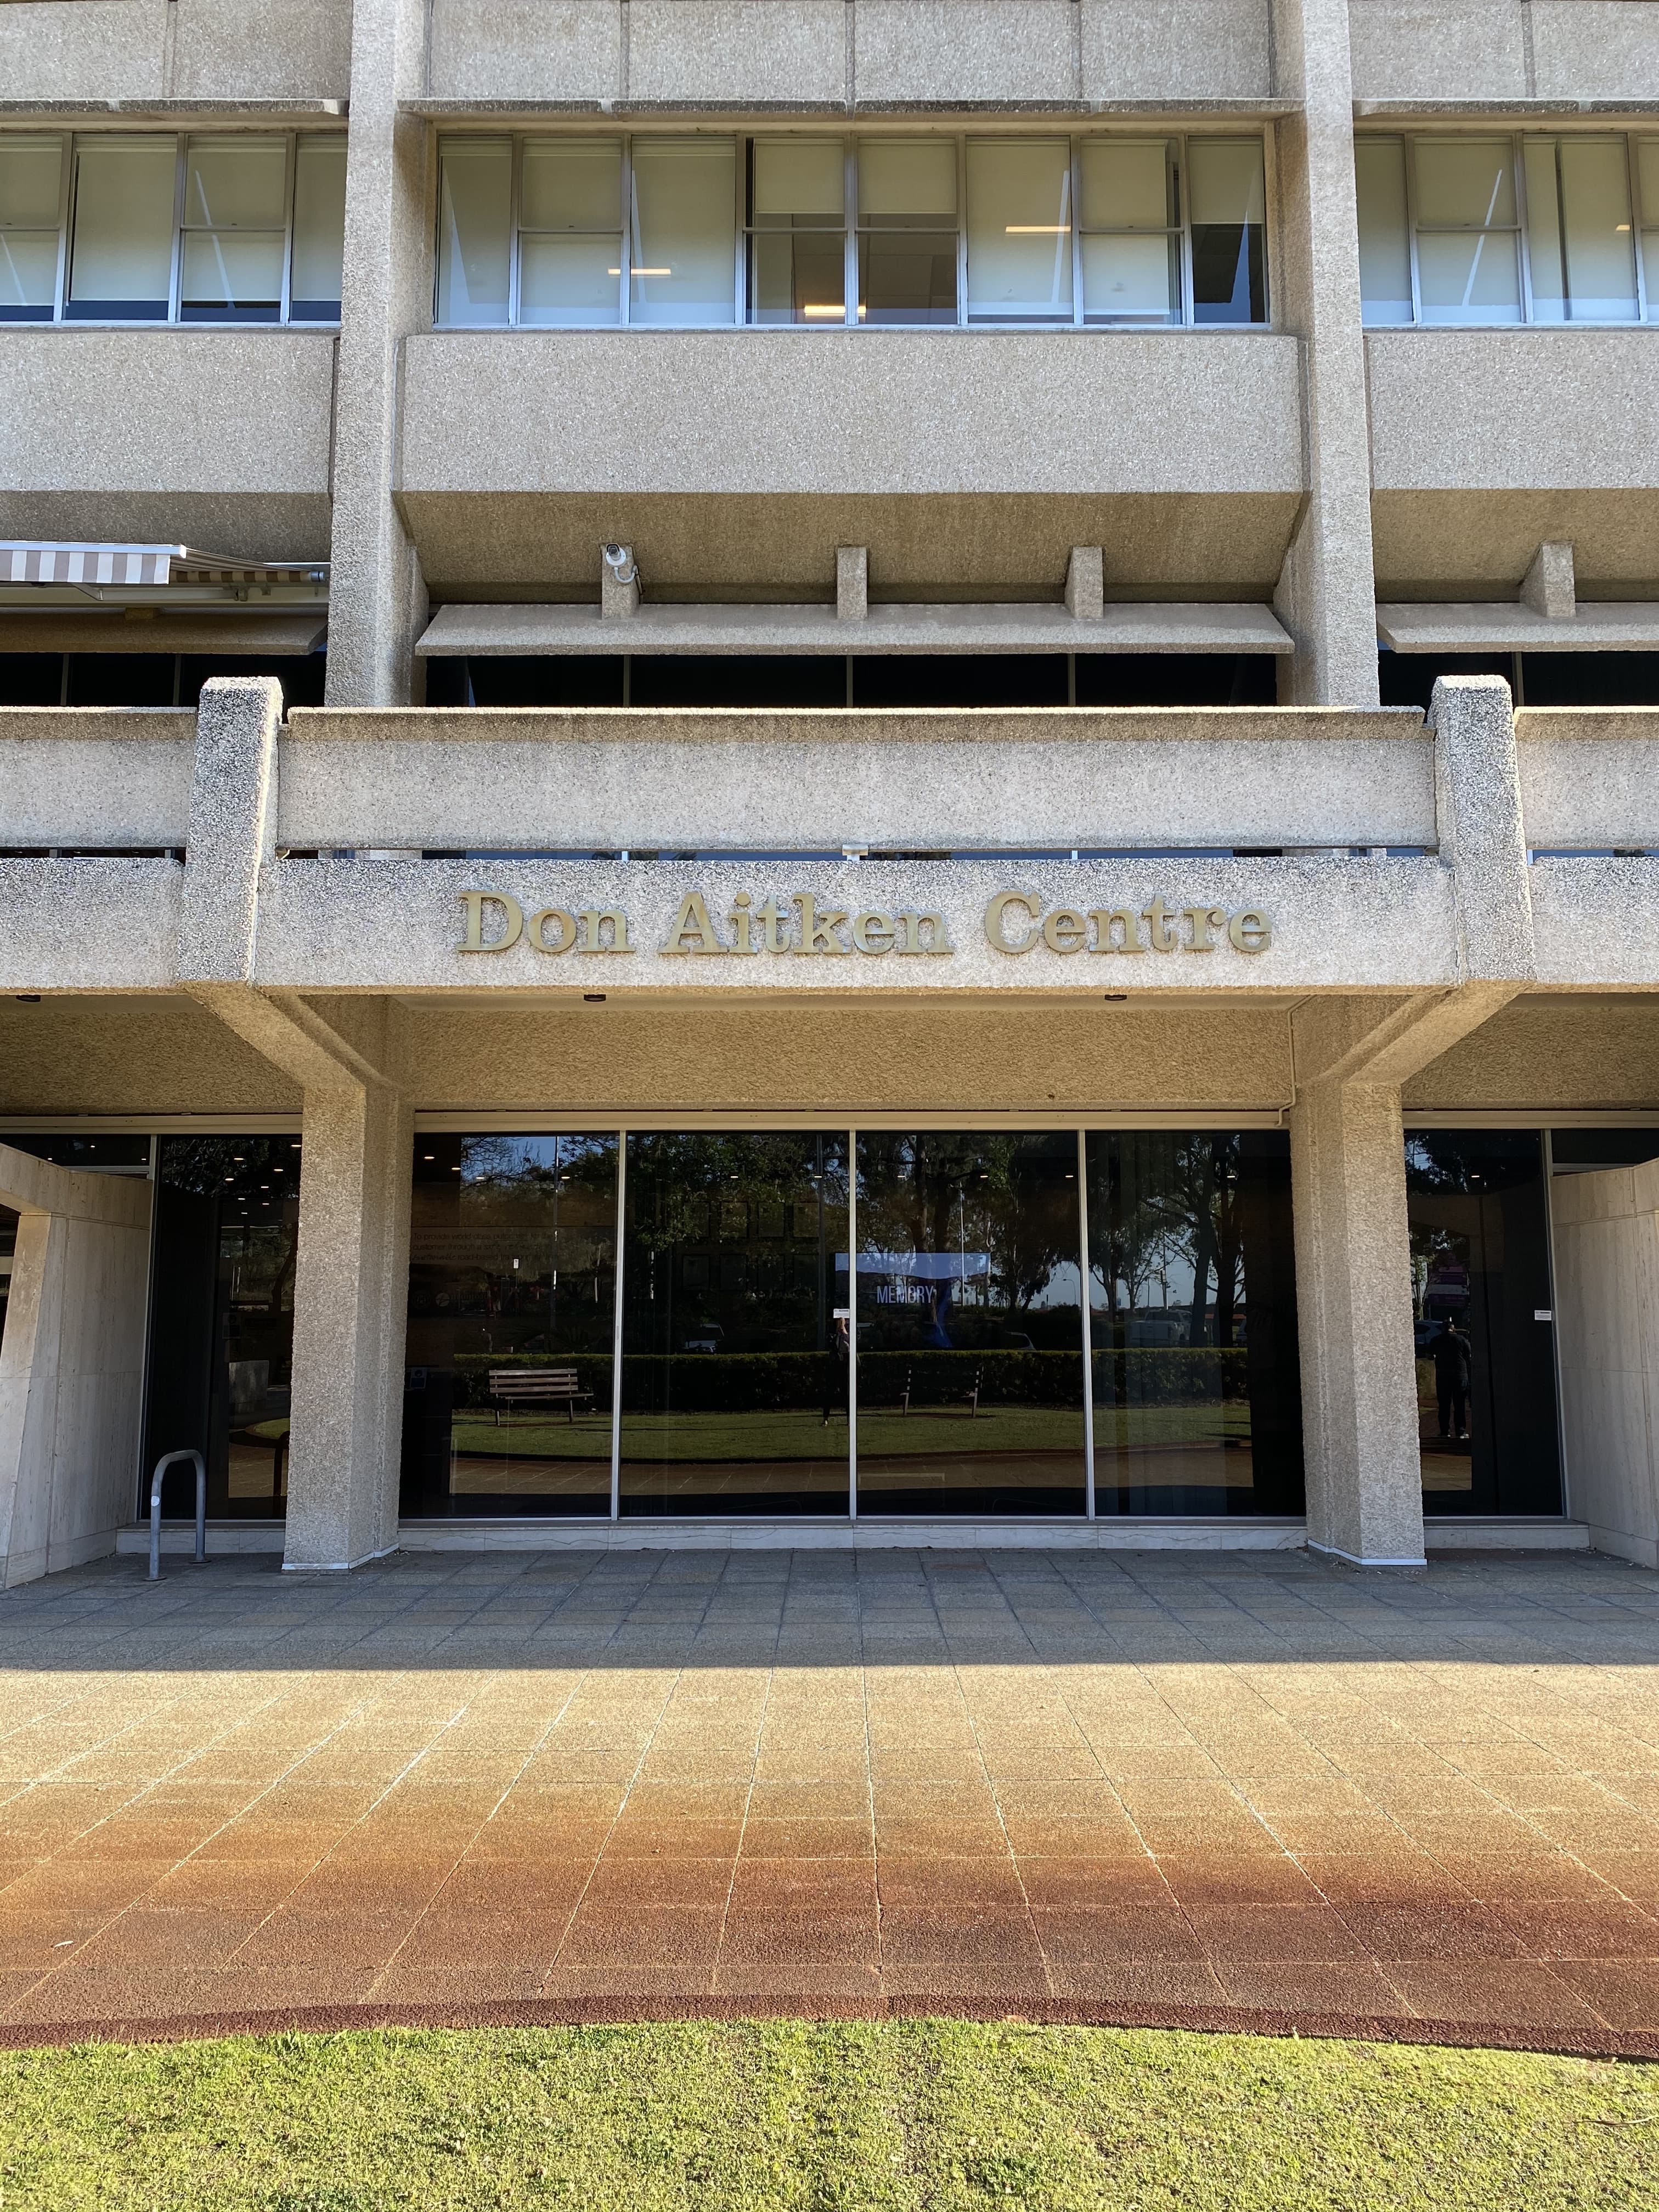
[403,1128,1303,1520]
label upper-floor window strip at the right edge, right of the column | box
[1354,133,1659,325]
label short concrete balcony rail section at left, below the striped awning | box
[0,708,197,847]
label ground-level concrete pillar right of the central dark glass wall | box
[1290,1080,1423,1566]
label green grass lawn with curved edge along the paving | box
[0,2019,1659,2212]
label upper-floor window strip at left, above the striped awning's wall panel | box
[0,133,345,323]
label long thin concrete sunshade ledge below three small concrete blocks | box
[416,602,1294,657]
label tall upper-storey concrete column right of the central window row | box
[1272,0,1378,706]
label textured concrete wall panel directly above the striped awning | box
[0,331,334,560]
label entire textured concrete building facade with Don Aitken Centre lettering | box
[0,0,1659,1579]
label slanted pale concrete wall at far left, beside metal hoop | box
[0,1144,150,1588]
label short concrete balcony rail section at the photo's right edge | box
[1515,708,1659,851]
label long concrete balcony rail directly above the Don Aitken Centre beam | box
[276,708,1436,851]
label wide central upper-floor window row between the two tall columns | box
[436,133,1267,330]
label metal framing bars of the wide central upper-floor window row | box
[431,117,1283,334]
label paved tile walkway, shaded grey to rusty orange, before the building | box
[0,1550,1659,2053]
